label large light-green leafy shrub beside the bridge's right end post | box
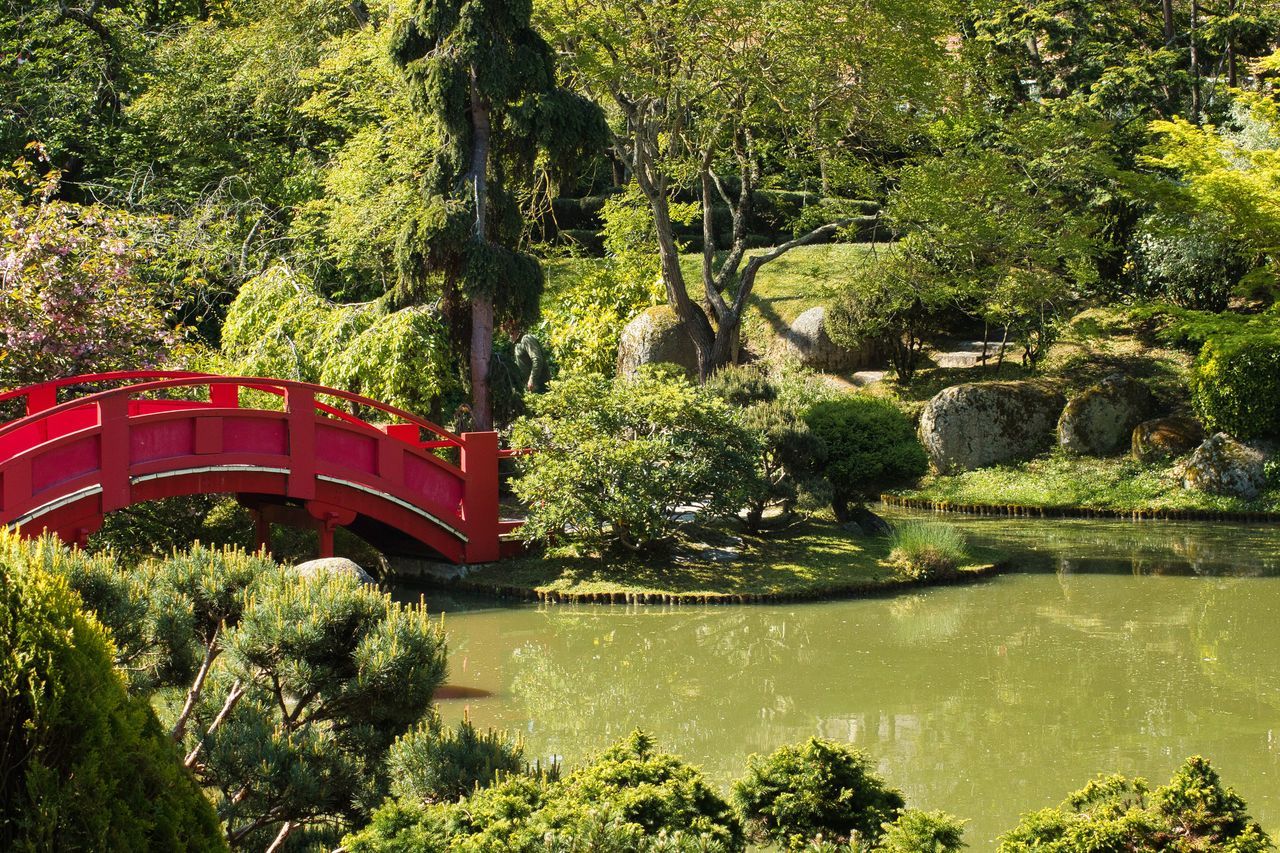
[512,368,758,548]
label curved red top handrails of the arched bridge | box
[0,370,463,447]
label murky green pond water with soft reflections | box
[414,512,1280,850]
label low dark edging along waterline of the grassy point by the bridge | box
[392,564,1004,605]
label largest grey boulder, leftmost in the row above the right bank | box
[920,382,1066,473]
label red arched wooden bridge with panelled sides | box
[0,371,518,564]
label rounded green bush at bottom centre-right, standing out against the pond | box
[733,738,905,850]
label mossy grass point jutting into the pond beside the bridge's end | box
[450,519,997,603]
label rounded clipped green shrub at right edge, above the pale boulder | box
[1192,330,1280,439]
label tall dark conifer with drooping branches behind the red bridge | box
[392,0,605,429]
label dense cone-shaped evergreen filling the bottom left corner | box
[0,533,225,853]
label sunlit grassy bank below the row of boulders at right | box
[893,453,1280,514]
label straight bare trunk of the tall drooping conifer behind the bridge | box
[467,69,494,430]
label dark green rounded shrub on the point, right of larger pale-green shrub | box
[805,394,928,520]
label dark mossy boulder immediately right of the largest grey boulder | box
[1057,374,1156,456]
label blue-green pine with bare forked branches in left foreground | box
[186,563,445,845]
